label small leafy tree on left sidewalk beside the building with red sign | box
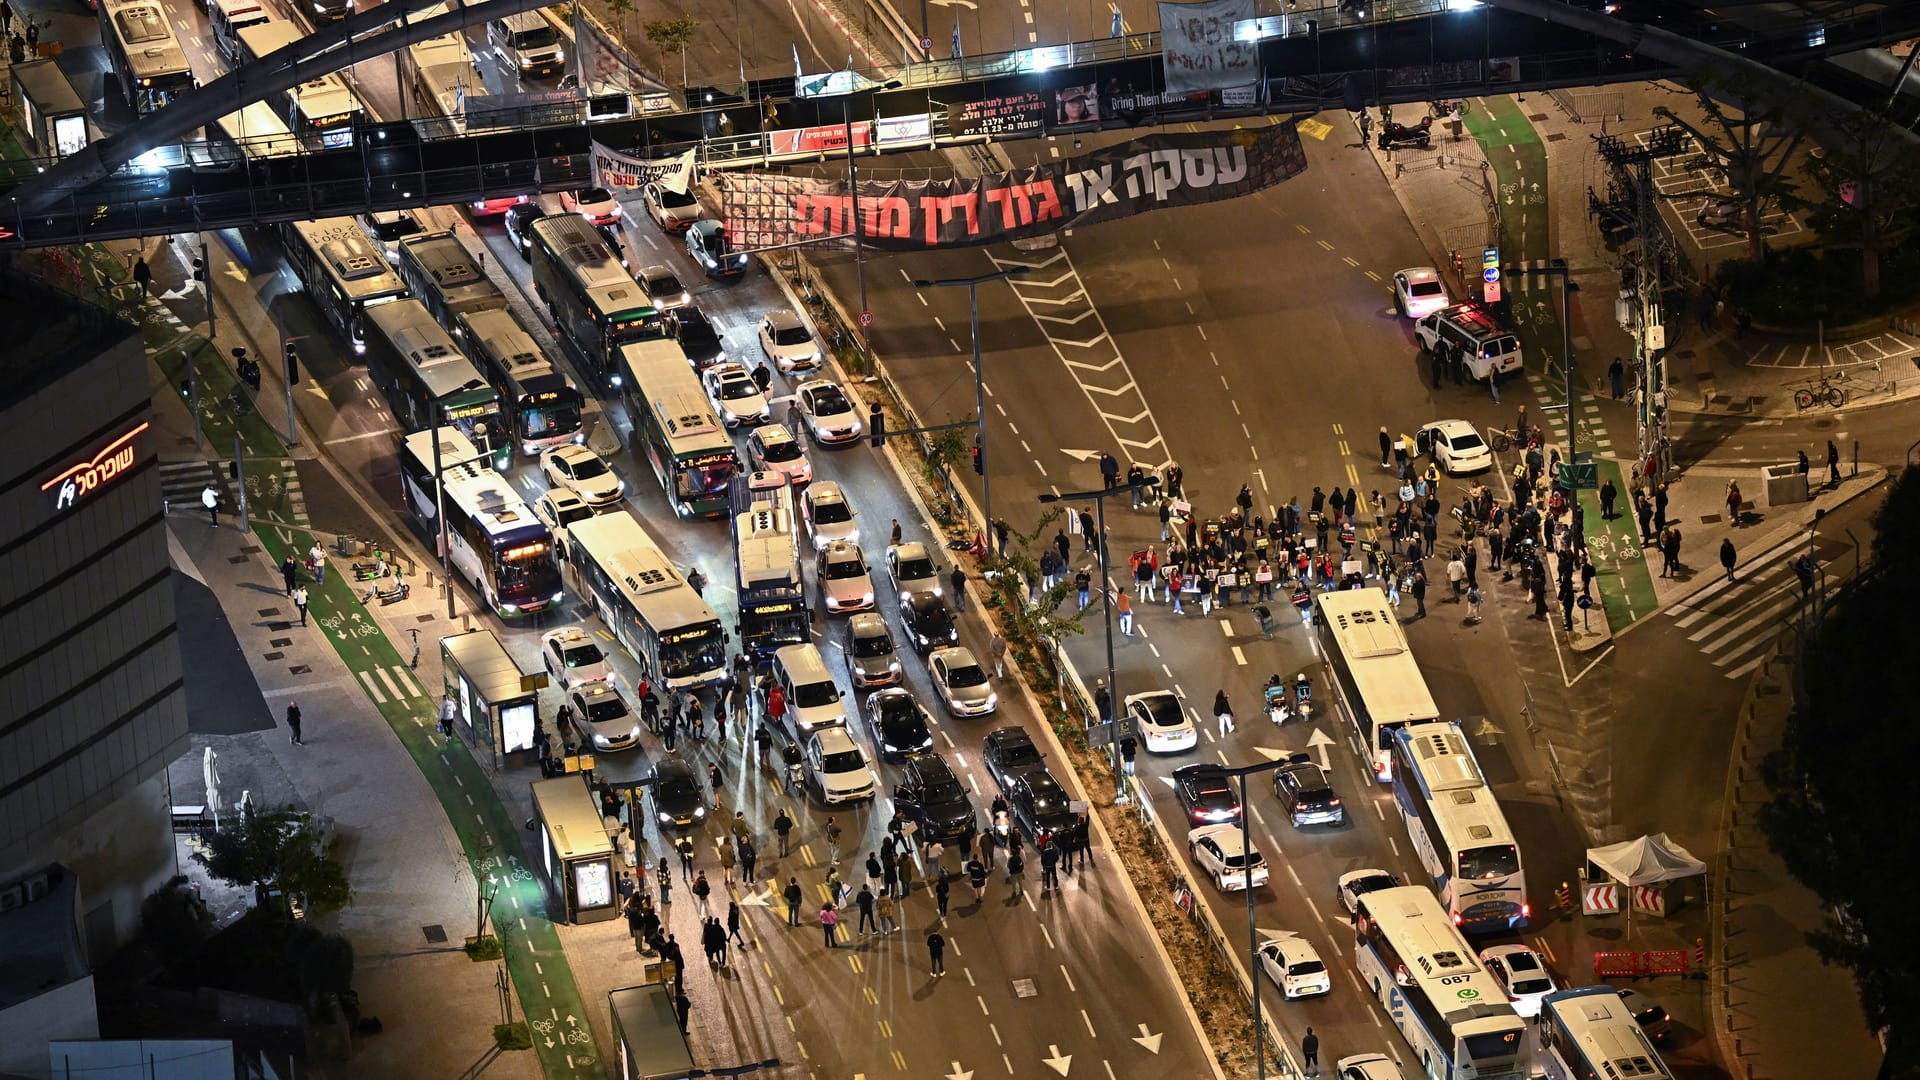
[194,807,353,913]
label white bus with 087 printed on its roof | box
[1354,886,1528,1080]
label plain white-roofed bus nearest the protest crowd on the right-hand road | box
[1315,588,1440,784]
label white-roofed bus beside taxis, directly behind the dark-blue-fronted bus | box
[616,340,739,517]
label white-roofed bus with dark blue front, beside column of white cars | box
[728,473,814,663]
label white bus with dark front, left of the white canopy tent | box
[1394,723,1532,934]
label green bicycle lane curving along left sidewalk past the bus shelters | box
[146,278,605,1080]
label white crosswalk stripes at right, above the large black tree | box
[1667,538,1845,678]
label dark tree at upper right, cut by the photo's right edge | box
[1799,110,1920,300]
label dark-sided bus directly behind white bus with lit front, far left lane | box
[367,298,513,457]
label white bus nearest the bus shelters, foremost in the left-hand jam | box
[564,509,728,690]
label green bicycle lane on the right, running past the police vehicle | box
[1465,94,1659,630]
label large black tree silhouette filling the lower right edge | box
[1761,471,1920,1076]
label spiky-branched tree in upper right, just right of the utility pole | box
[1653,81,1805,265]
